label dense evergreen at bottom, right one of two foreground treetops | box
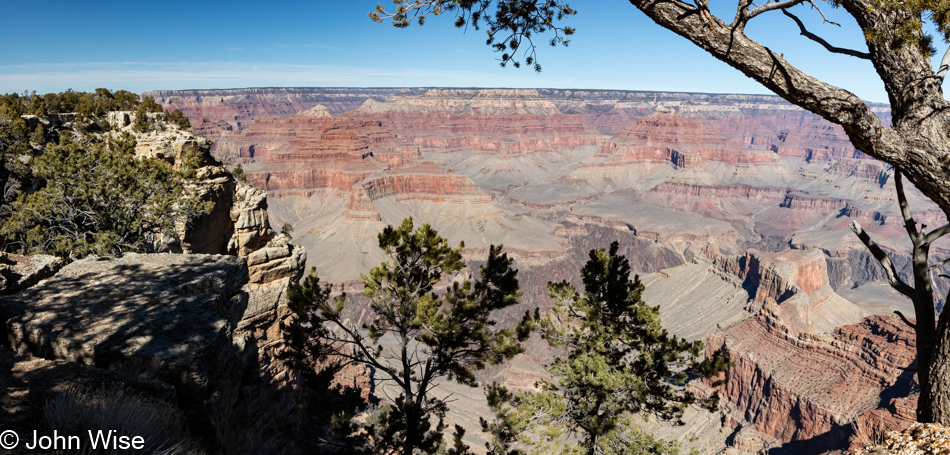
[482,242,729,455]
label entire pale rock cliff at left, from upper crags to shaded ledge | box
[0,112,306,454]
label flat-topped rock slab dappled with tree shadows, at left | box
[2,254,253,453]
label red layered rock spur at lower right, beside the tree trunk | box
[706,316,916,453]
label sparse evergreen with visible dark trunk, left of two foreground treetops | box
[287,218,531,455]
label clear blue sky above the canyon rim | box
[0,0,944,102]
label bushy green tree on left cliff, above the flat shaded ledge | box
[0,133,213,259]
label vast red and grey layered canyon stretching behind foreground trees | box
[148,88,950,454]
